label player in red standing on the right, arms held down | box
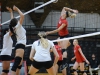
[71,39,89,75]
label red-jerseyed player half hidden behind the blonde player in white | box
[55,42,66,75]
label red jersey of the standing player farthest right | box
[74,45,85,63]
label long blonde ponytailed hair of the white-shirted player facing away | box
[38,32,49,49]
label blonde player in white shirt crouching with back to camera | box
[29,32,59,75]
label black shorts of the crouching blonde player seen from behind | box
[32,60,53,69]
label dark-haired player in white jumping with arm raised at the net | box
[9,6,26,75]
